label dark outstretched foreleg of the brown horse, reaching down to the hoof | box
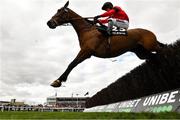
[51,50,92,87]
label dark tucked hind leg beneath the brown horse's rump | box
[131,45,156,59]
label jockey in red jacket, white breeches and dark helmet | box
[94,2,129,34]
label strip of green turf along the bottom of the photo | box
[0,112,180,119]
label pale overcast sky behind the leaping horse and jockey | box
[0,0,180,104]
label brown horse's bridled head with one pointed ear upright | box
[47,1,70,29]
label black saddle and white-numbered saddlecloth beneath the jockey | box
[96,25,128,36]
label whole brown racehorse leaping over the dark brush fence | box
[47,1,162,87]
